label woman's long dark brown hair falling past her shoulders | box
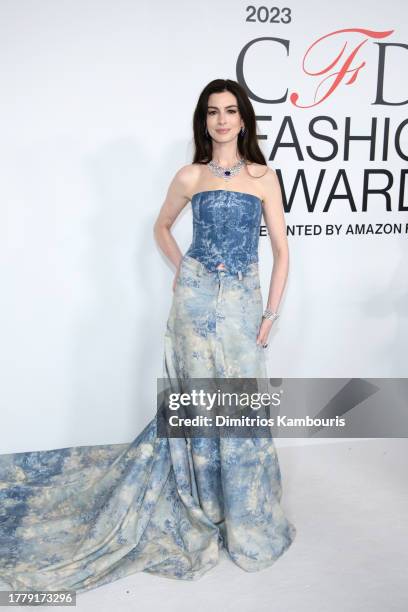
[193,79,267,166]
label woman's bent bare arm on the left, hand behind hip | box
[153,166,192,272]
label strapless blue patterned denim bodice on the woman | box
[186,189,262,273]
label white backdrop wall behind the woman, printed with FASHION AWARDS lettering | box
[0,0,408,452]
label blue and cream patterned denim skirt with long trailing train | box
[0,194,296,592]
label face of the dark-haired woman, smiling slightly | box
[207,91,244,142]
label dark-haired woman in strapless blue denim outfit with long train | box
[0,80,295,592]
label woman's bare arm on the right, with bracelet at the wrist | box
[257,168,289,344]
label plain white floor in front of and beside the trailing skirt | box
[18,439,408,612]
